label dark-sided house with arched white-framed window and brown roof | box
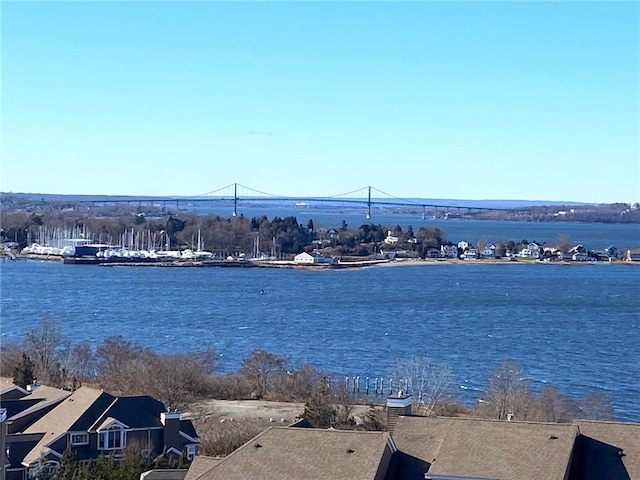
[5,387,199,480]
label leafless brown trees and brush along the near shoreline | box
[5,317,613,428]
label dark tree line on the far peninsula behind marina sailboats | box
[0,205,592,258]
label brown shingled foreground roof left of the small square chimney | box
[188,427,395,480]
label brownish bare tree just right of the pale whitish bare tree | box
[480,360,532,420]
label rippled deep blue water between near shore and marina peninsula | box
[1,261,640,421]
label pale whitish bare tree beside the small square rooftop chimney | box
[392,355,455,417]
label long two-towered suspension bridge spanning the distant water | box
[62,183,516,219]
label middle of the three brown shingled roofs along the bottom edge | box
[393,416,578,480]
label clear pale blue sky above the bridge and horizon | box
[0,1,640,203]
